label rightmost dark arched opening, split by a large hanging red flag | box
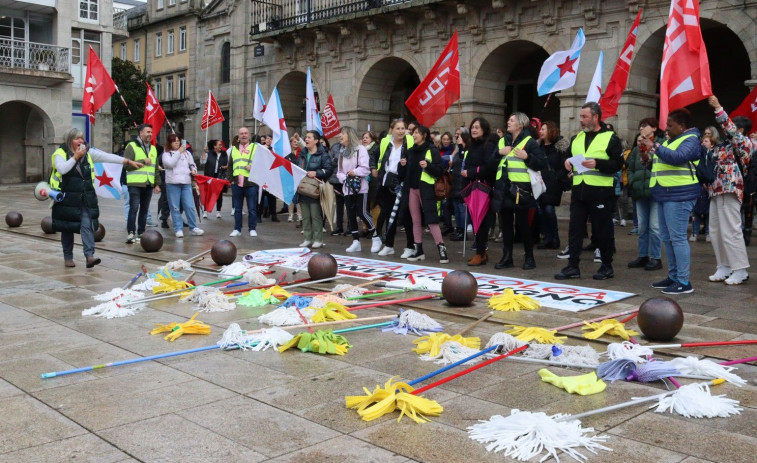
[629,18,751,128]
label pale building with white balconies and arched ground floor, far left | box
[0,0,119,183]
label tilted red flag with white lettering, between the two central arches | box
[405,31,460,127]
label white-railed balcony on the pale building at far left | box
[0,38,70,73]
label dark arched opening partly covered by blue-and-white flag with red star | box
[473,40,560,131]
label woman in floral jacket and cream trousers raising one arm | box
[707,96,752,285]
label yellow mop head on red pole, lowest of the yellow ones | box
[344,377,443,423]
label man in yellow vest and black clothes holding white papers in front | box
[555,102,623,280]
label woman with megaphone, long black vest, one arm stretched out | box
[50,129,142,268]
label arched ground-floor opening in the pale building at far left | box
[0,101,54,184]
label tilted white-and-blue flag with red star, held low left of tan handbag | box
[250,144,306,204]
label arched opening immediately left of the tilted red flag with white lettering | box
[357,57,421,133]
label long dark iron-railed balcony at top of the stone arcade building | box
[250,0,411,37]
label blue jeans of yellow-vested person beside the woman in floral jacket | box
[657,199,696,284]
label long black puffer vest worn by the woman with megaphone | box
[52,145,100,233]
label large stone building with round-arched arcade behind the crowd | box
[195,0,757,147]
